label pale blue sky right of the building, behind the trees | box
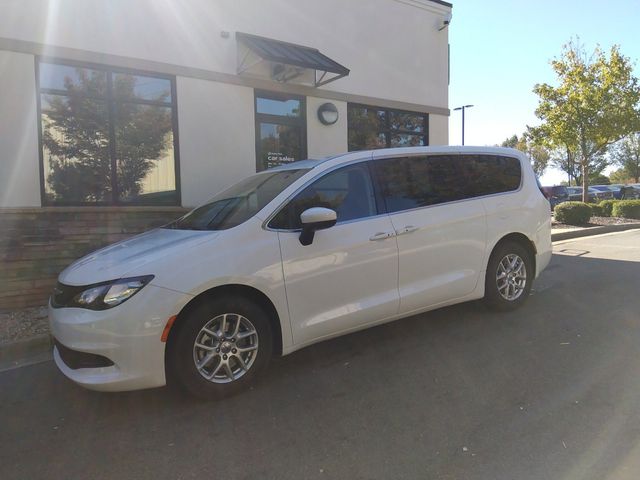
[449,0,640,185]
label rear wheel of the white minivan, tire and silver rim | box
[484,242,535,312]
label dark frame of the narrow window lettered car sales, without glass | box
[253,89,307,173]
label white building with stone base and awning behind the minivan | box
[0,0,452,308]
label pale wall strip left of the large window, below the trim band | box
[0,50,40,208]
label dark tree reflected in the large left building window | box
[42,69,172,203]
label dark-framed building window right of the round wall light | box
[347,103,429,151]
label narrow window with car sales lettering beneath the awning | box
[255,92,307,171]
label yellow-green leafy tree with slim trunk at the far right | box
[531,42,640,201]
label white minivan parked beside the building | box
[49,147,551,398]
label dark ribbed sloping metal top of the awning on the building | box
[236,32,349,76]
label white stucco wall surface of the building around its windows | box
[0,0,450,207]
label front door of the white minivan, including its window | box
[268,162,399,344]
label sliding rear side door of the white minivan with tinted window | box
[371,154,486,313]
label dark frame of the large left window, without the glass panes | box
[34,55,182,207]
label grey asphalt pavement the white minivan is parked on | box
[0,230,640,480]
